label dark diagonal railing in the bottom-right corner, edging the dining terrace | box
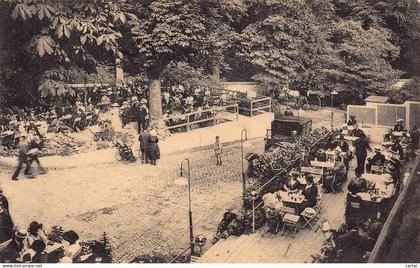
[368,154,420,263]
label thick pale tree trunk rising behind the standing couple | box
[148,71,162,119]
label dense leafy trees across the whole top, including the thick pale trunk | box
[0,0,420,117]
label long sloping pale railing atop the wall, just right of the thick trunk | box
[163,104,239,130]
